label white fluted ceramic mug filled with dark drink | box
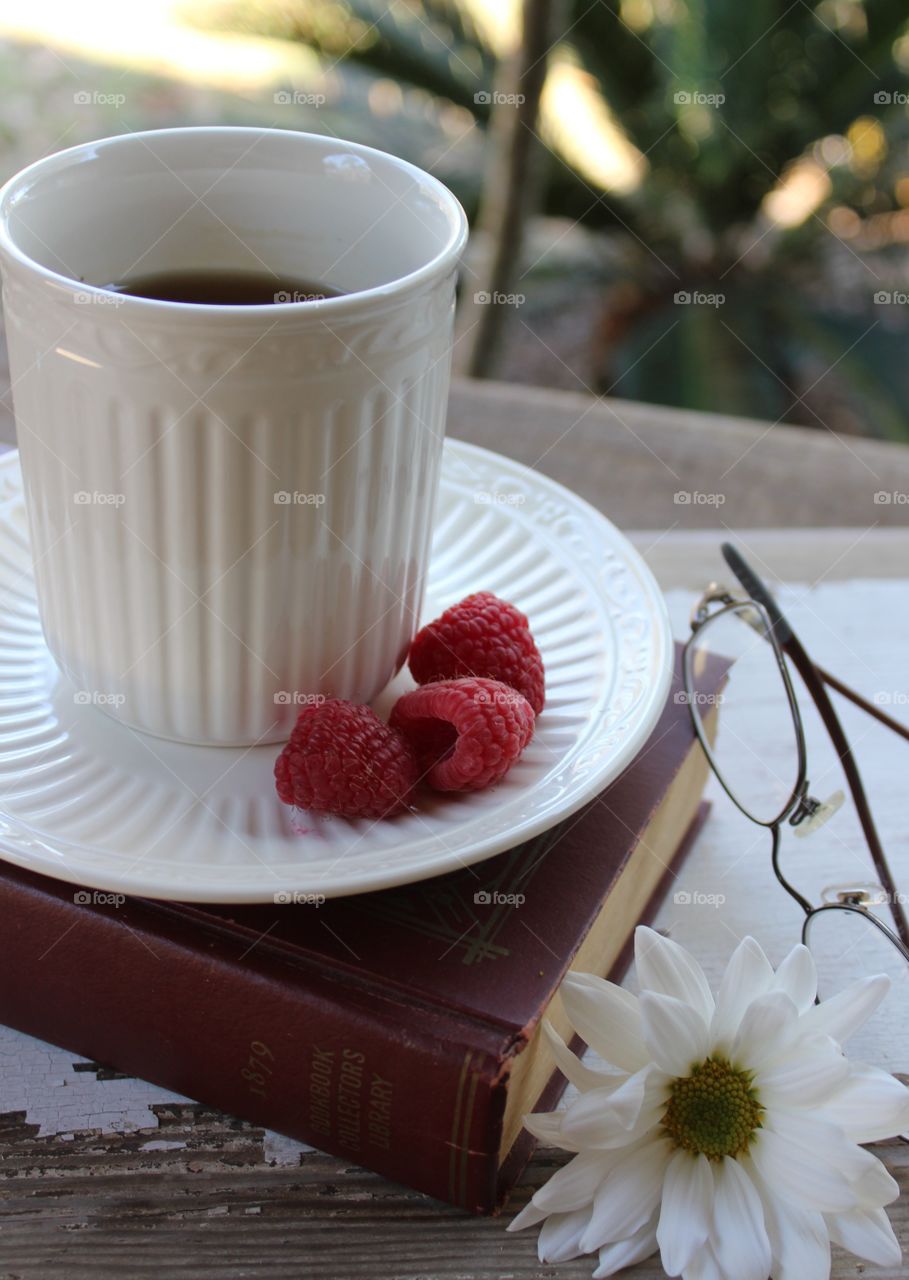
[0,128,466,745]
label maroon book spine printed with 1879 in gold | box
[0,873,507,1212]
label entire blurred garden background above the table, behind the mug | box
[0,0,909,440]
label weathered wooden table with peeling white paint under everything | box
[0,384,909,1280]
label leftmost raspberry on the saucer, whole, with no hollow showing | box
[274,698,417,818]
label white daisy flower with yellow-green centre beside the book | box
[508,927,909,1280]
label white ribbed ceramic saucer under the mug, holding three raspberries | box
[0,440,672,902]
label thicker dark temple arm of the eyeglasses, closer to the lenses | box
[721,543,909,946]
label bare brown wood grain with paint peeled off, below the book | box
[0,1131,909,1280]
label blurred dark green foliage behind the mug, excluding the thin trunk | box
[197,0,909,439]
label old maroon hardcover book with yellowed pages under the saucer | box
[0,654,722,1212]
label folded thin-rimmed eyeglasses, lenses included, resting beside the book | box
[684,543,909,1065]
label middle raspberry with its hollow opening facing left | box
[389,677,535,791]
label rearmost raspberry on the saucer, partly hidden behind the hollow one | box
[408,591,545,716]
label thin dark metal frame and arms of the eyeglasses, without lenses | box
[682,543,909,964]
